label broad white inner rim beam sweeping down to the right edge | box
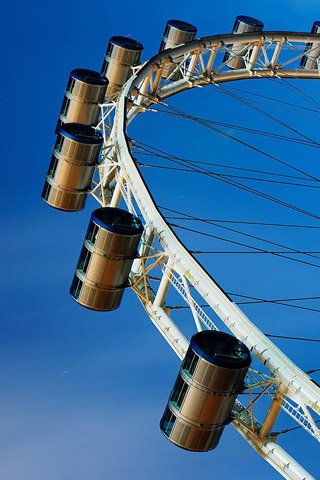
[115,86,320,413]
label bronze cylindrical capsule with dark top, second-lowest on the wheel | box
[70,207,143,311]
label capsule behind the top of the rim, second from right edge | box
[223,15,264,69]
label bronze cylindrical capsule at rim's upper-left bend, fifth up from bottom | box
[101,36,143,99]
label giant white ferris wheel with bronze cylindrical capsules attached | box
[42,16,320,480]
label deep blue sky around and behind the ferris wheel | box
[0,0,320,480]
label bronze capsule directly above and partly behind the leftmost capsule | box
[57,68,109,129]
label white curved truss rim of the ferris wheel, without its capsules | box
[92,32,320,480]
